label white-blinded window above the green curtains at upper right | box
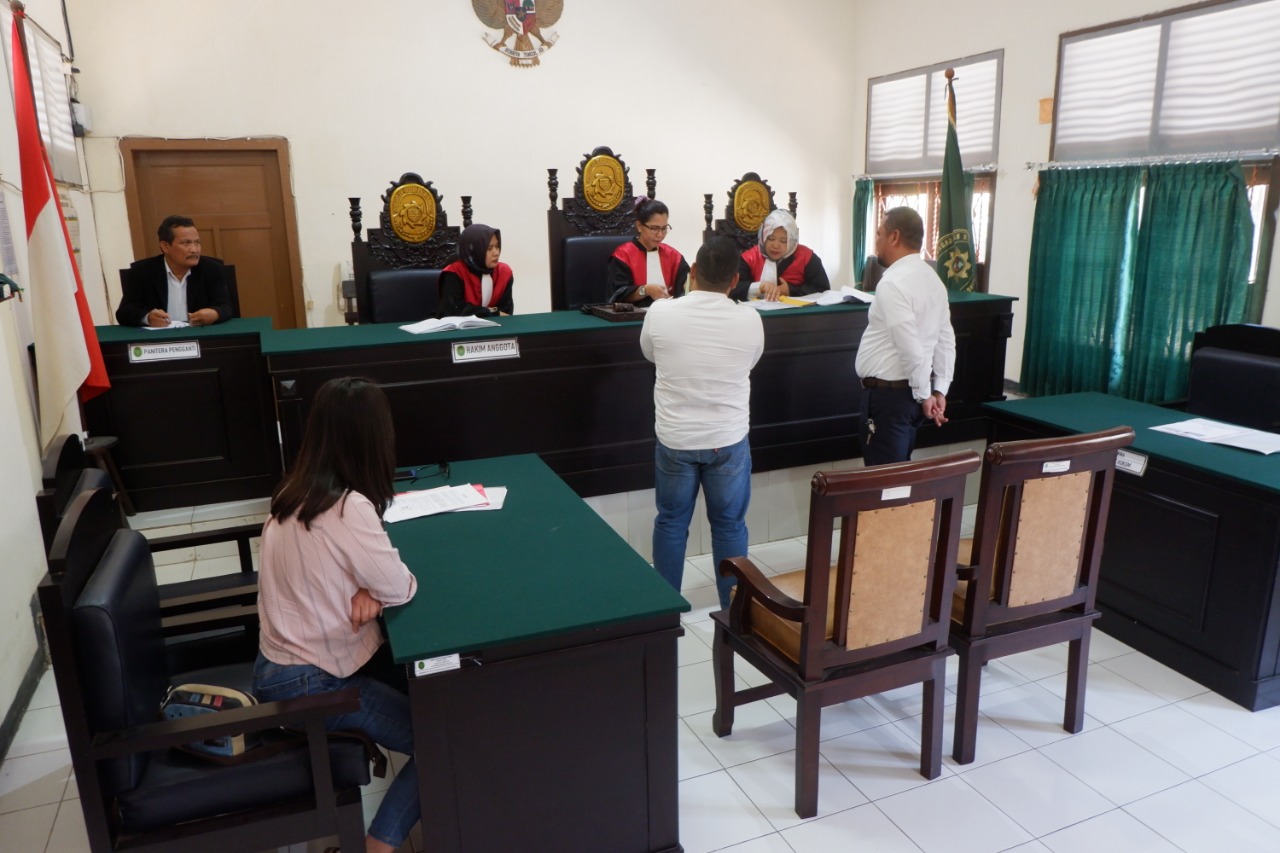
[1049,0,1280,160]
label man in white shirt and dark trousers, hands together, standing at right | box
[854,207,956,465]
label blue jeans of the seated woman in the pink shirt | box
[253,652,422,848]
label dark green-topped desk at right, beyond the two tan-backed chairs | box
[989,394,1280,711]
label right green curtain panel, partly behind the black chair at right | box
[1120,163,1253,402]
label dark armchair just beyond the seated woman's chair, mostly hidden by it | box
[49,488,262,670]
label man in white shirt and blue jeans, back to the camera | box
[640,237,764,607]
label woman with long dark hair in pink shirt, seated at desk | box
[253,378,421,853]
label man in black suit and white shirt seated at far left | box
[115,216,232,327]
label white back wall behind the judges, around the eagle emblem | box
[68,0,860,325]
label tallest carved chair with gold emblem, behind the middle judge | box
[547,146,658,311]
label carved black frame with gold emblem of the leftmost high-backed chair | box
[348,172,471,323]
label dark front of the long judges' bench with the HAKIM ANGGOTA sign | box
[264,295,1012,497]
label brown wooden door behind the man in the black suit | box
[120,138,306,329]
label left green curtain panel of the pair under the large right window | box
[1020,167,1142,396]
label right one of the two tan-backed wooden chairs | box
[951,427,1133,765]
